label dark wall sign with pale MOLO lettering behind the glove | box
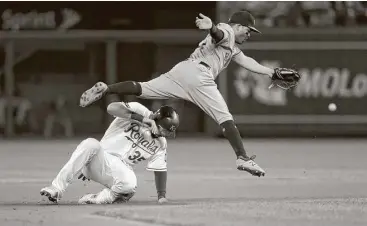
[225,50,367,124]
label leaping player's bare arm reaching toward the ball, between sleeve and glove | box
[233,52,274,78]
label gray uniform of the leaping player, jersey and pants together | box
[139,23,241,124]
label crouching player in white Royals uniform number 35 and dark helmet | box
[40,102,179,204]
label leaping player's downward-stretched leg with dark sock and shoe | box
[190,79,265,176]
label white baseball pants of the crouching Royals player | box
[52,138,137,203]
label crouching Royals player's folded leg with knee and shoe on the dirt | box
[78,153,137,204]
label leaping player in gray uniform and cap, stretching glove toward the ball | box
[80,11,300,177]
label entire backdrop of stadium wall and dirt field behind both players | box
[0,1,367,226]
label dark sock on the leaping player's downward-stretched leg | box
[220,120,248,158]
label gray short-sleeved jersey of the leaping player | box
[190,23,241,78]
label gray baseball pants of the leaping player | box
[139,60,233,124]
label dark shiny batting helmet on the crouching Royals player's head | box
[155,106,180,138]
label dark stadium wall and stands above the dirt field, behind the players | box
[0,2,367,138]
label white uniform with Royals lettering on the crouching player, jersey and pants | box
[52,102,167,203]
